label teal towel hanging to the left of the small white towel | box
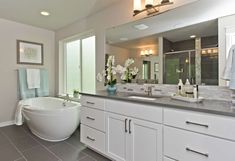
[18,68,36,99]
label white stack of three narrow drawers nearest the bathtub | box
[81,96,105,154]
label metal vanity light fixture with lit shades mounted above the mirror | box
[133,0,173,16]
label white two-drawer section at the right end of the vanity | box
[163,108,235,161]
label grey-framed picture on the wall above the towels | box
[16,40,44,65]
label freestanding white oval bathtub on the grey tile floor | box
[22,97,80,142]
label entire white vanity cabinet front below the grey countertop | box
[81,93,235,161]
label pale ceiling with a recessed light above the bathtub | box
[0,0,120,30]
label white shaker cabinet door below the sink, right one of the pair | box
[128,118,162,161]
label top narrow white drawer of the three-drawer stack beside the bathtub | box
[81,95,105,110]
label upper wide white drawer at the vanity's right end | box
[164,108,235,140]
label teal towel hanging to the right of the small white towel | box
[36,69,49,97]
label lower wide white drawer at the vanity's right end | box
[164,127,235,161]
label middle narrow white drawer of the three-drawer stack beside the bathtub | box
[81,106,105,131]
